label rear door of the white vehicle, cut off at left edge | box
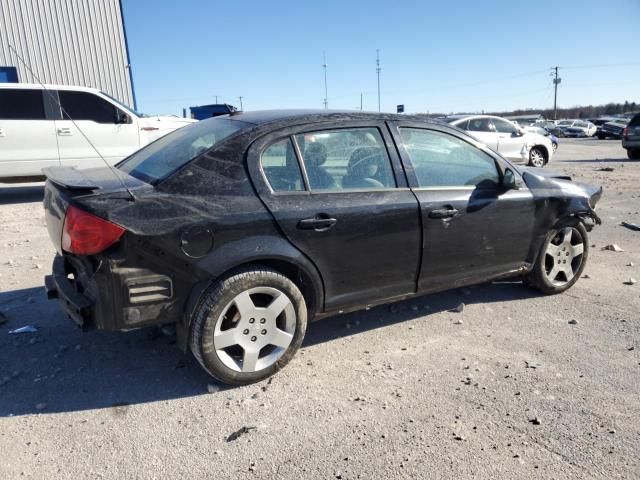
[0,88,59,177]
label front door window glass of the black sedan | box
[400,128,500,188]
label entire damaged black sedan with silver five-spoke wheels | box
[44,111,602,384]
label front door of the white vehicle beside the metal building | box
[55,90,140,168]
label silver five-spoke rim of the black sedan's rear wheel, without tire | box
[213,287,296,373]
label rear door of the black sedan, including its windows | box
[249,123,421,311]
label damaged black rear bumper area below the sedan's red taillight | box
[45,255,182,331]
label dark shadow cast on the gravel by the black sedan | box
[0,282,537,417]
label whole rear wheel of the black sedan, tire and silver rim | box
[190,267,307,385]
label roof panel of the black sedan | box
[217,109,442,125]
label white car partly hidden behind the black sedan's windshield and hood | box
[443,115,554,167]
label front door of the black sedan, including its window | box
[394,123,534,292]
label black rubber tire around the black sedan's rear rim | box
[190,266,307,385]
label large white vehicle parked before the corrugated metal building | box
[0,83,195,182]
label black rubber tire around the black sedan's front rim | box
[524,218,589,295]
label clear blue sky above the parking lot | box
[123,0,640,113]
